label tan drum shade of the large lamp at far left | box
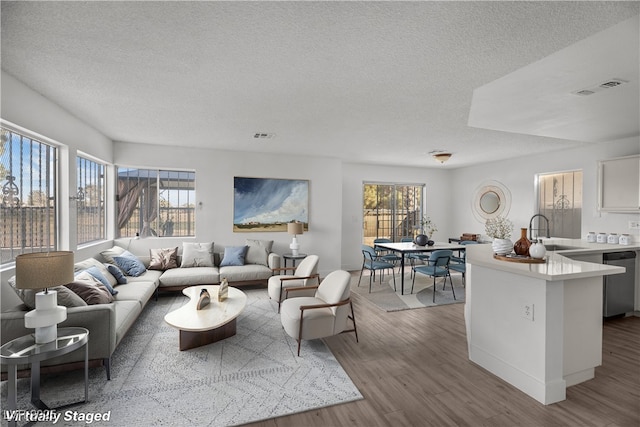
[16,251,73,289]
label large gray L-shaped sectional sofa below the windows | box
[0,240,280,379]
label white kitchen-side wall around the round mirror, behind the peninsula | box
[451,137,640,241]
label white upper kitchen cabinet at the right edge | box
[598,155,640,212]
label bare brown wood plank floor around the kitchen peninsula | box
[245,278,640,427]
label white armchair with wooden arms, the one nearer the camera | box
[280,270,358,356]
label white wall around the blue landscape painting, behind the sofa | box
[114,142,342,276]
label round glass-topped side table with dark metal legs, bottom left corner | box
[0,328,89,426]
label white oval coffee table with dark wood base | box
[164,285,247,350]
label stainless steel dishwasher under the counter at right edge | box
[602,251,636,317]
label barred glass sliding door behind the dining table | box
[363,183,424,245]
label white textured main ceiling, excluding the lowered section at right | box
[2,1,640,167]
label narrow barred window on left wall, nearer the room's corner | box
[75,156,105,244]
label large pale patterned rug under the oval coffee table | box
[2,289,362,426]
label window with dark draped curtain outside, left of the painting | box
[117,168,196,237]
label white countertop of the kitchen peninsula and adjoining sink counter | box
[466,239,640,281]
